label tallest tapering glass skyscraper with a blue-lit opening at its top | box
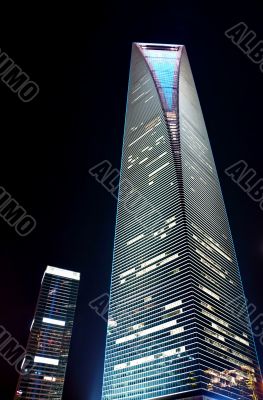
[103,43,262,400]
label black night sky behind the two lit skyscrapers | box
[0,0,263,400]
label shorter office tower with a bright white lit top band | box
[15,266,80,400]
